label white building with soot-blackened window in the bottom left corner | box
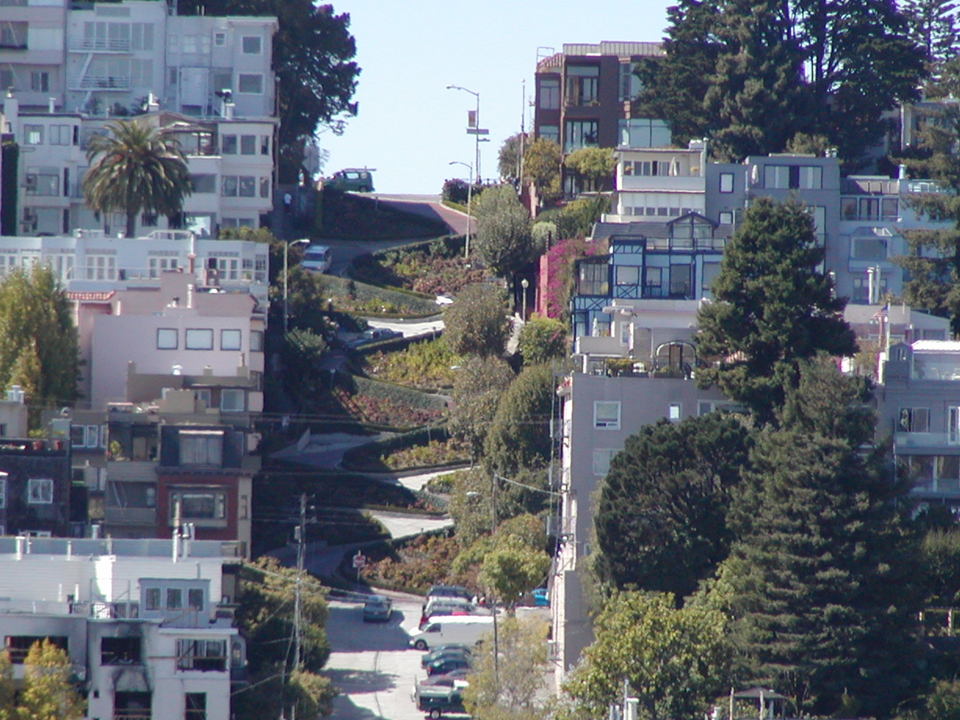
[0,537,246,720]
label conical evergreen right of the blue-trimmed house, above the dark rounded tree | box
[697,198,856,423]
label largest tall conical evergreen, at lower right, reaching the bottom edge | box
[712,358,920,716]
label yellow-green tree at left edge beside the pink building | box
[0,265,80,406]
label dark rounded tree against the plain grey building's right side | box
[594,413,750,597]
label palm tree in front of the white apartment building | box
[83,120,191,237]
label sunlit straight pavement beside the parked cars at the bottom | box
[325,593,424,720]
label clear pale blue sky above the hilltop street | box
[320,0,675,193]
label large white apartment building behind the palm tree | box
[0,0,277,236]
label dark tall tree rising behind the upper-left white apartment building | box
[178,0,360,183]
